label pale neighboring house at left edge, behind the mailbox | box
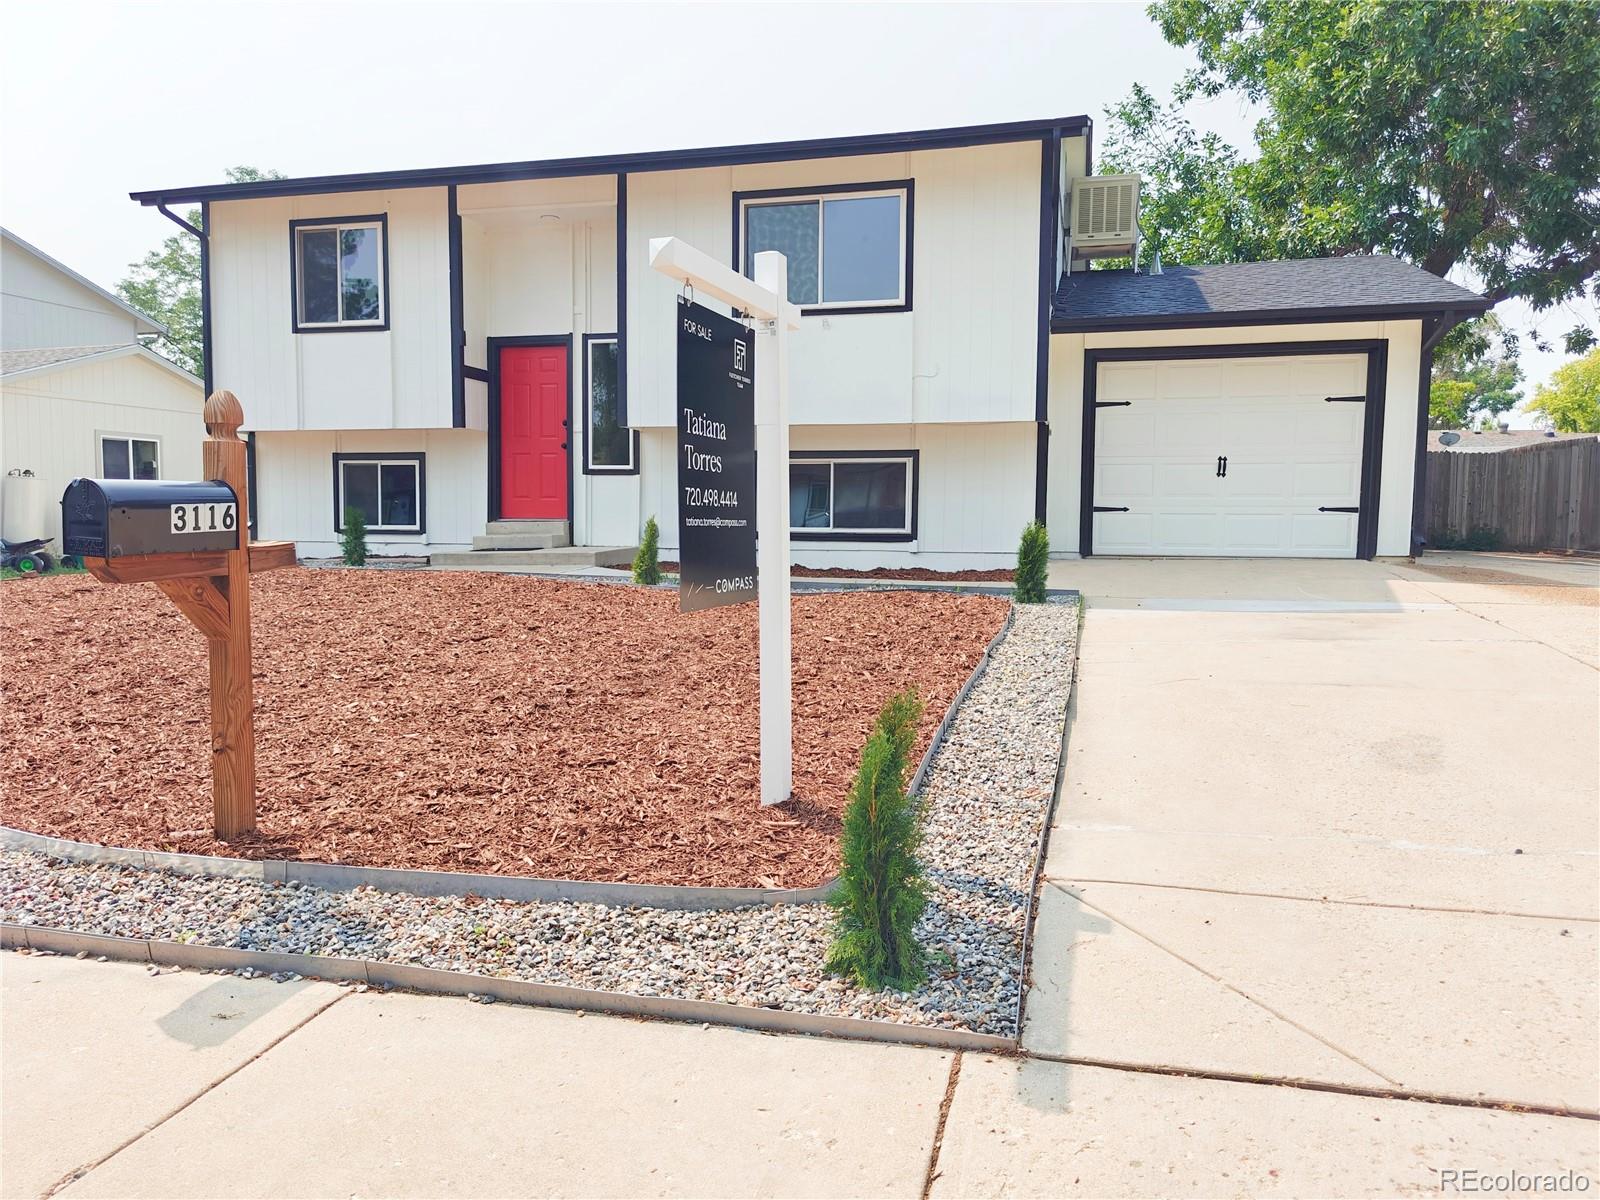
[0,229,205,549]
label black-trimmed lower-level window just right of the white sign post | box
[789,450,917,541]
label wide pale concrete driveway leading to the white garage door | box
[1024,555,1600,1114]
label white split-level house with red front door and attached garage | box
[124,117,1486,568]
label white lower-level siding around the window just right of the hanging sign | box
[640,421,1035,568]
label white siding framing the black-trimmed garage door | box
[1046,320,1422,555]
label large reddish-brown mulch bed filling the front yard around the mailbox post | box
[0,570,1005,886]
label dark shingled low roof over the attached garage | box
[1050,254,1490,333]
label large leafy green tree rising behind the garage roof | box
[1107,0,1600,354]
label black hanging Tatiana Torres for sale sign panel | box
[677,301,755,613]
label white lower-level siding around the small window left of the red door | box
[256,429,488,557]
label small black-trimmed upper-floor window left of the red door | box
[290,216,389,333]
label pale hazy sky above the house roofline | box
[0,0,1597,424]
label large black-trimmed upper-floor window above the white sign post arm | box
[734,181,912,312]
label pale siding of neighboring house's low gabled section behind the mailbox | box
[0,354,205,549]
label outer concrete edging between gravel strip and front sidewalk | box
[0,923,1018,1053]
